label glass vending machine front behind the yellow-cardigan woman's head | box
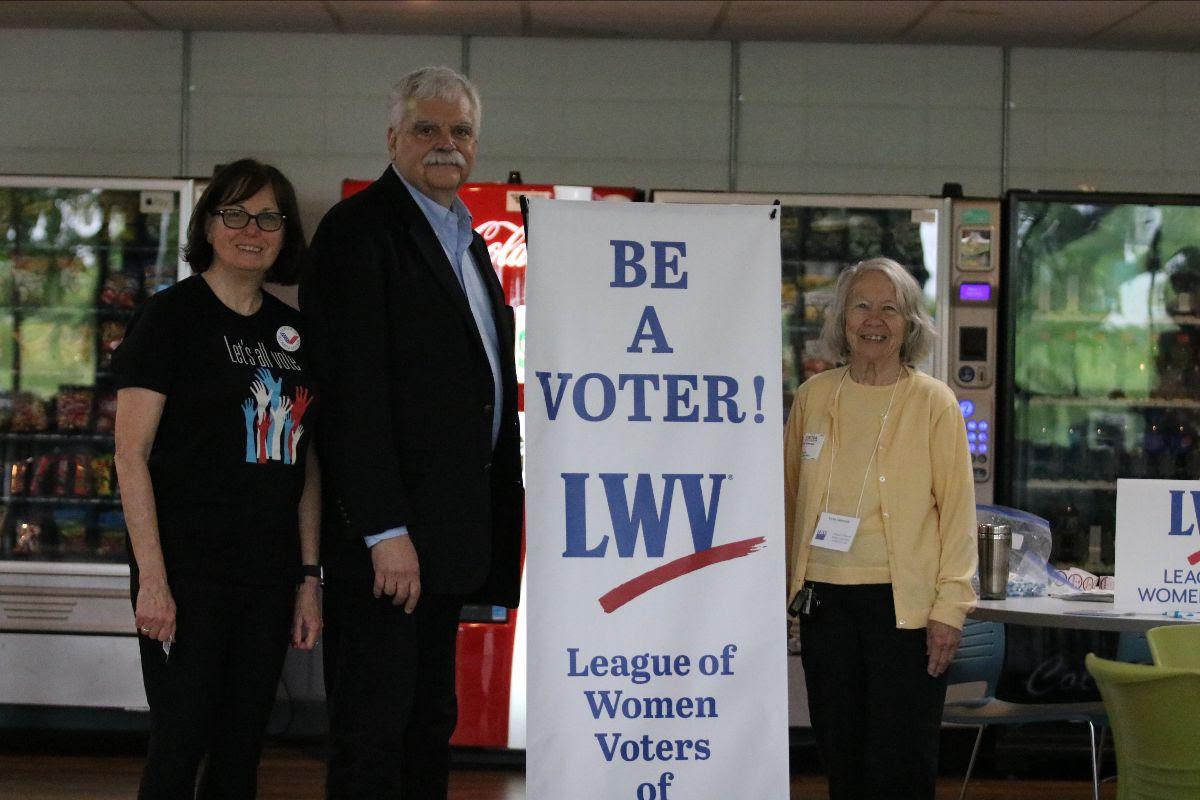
[654,192,947,419]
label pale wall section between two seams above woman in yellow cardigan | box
[738,43,1003,197]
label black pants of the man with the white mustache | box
[325,582,463,800]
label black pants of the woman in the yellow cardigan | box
[800,583,946,800]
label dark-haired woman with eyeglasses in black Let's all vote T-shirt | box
[113,160,322,800]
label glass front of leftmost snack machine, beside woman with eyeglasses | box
[0,179,191,571]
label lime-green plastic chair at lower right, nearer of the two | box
[1086,652,1200,800]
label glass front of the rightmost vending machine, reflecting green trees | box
[1006,193,1200,575]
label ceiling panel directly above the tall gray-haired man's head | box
[328,0,522,36]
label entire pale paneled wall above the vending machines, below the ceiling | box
[0,29,1200,234]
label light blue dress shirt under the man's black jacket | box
[364,164,504,547]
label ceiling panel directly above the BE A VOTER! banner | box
[528,0,725,38]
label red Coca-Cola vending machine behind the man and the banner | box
[342,173,643,750]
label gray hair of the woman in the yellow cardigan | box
[821,258,937,365]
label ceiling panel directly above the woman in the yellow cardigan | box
[719,0,937,42]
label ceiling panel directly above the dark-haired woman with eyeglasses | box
[130,0,337,34]
